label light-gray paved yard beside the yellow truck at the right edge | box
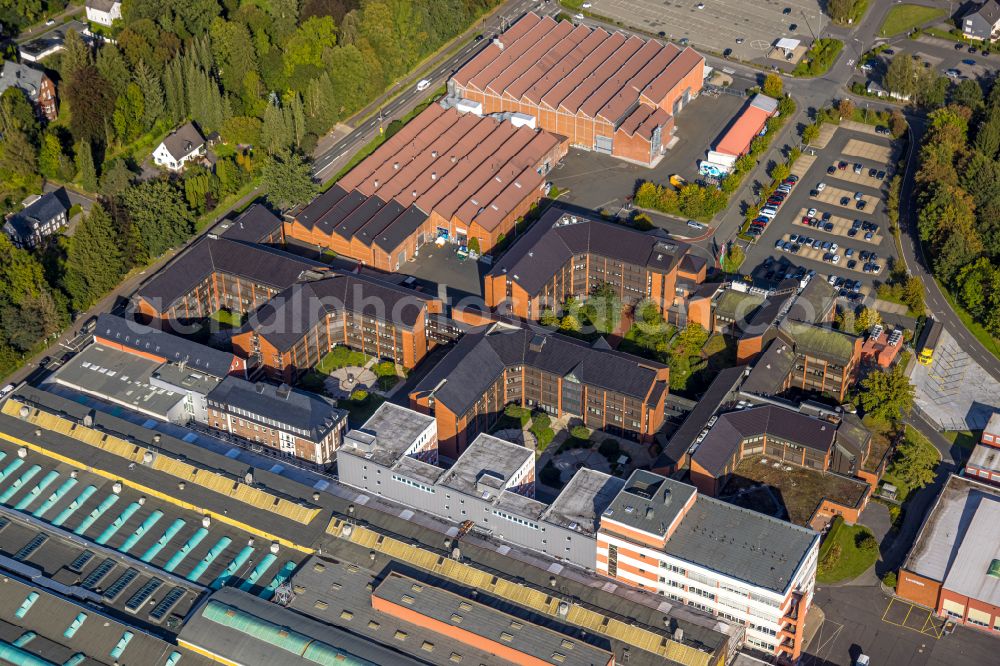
[910,330,1000,430]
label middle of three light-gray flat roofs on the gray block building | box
[439,433,535,497]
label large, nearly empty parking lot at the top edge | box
[590,0,827,62]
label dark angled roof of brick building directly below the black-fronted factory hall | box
[243,271,431,351]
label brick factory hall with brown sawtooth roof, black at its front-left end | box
[285,104,566,264]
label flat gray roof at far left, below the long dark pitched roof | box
[50,343,185,420]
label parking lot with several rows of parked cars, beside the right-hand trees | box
[744,120,895,304]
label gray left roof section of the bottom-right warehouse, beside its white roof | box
[904,474,1000,582]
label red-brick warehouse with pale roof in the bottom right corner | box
[896,475,1000,633]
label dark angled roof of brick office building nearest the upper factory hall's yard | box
[490,207,697,295]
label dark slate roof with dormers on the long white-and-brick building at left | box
[208,376,347,442]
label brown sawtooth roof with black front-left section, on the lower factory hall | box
[297,104,559,246]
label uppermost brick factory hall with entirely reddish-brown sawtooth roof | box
[448,12,705,166]
